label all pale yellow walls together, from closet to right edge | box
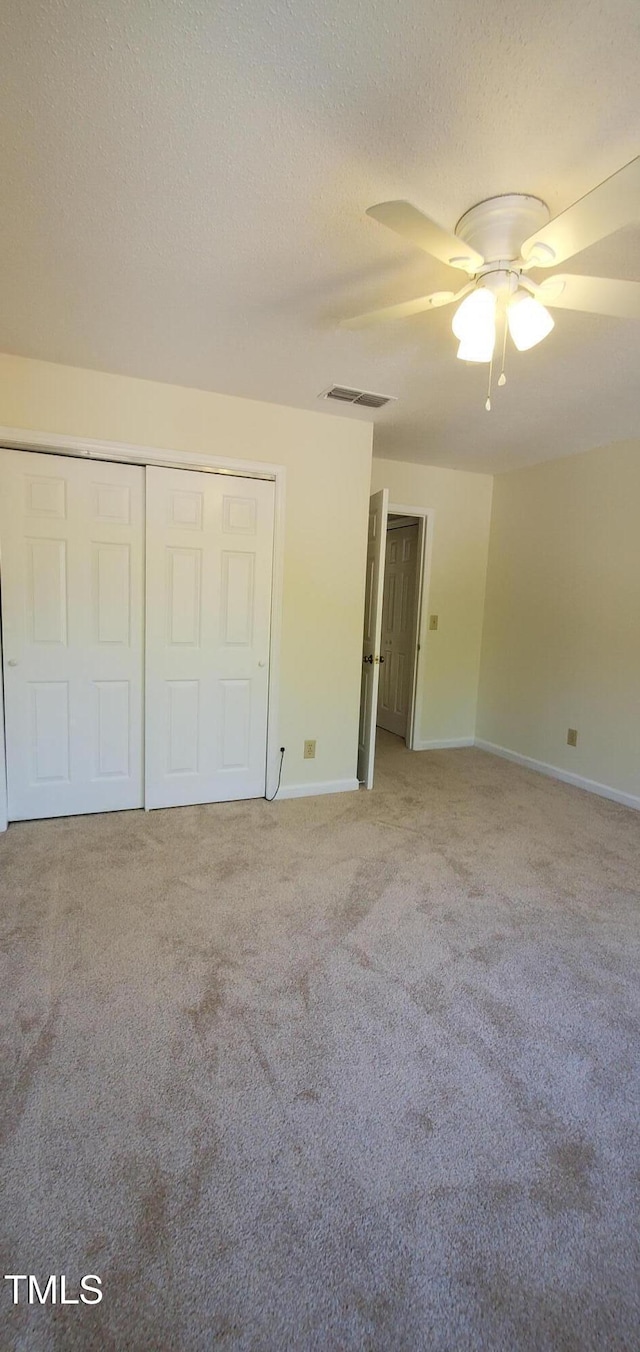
[0,356,627,798]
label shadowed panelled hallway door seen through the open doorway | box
[378,525,419,737]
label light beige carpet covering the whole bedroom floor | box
[0,734,640,1352]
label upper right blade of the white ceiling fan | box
[522,155,640,268]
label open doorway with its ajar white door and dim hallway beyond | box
[359,489,432,788]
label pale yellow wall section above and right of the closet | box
[0,356,372,786]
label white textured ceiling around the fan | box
[0,0,640,469]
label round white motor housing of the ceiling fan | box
[456,192,549,262]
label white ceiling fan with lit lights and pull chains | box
[346,157,640,408]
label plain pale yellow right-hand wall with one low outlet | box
[476,441,640,803]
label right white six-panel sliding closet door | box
[145,466,275,807]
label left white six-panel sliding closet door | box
[0,450,145,821]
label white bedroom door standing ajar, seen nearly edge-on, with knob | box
[357,488,388,788]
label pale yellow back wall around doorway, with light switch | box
[371,458,493,744]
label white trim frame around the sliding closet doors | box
[0,427,287,831]
